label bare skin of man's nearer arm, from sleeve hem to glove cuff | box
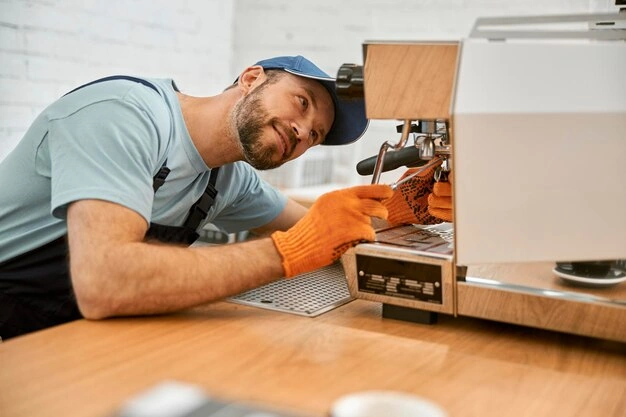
[67,200,283,319]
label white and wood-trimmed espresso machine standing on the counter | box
[337,13,626,342]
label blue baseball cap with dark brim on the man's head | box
[250,55,369,145]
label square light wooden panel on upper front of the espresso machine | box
[364,42,459,120]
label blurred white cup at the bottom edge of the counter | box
[330,391,448,417]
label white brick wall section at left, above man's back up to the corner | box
[0,0,234,160]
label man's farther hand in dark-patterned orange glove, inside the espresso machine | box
[384,162,452,226]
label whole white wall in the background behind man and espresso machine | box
[0,0,617,187]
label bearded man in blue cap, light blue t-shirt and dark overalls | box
[0,56,448,338]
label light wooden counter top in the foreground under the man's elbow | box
[0,300,626,417]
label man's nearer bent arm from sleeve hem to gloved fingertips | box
[67,185,393,319]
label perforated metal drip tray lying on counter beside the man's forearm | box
[228,263,353,317]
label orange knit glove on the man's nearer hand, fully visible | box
[271,185,393,277]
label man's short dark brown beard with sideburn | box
[233,85,296,170]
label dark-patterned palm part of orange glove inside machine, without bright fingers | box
[384,166,441,226]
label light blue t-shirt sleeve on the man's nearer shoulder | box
[48,94,168,222]
